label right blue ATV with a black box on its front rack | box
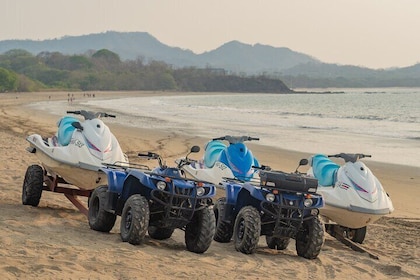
[213,159,324,259]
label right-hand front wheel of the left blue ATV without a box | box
[185,207,216,254]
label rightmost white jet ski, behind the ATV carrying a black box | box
[308,153,394,243]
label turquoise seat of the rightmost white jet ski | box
[312,155,340,186]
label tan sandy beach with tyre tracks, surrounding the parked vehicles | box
[0,92,420,279]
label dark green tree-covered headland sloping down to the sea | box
[0,49,291,93]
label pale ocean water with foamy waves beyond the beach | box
[32,88,420,167]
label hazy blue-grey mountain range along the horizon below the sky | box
[0,31,420,87]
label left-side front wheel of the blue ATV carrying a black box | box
[233,206,261,254]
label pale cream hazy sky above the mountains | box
[0,0,420,68]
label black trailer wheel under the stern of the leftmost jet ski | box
[22,164,44,206]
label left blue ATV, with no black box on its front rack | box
[88,146,216,253]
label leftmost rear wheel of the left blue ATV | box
[88,186,117,232]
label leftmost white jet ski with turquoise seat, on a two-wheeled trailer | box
[26,110,128,190]
